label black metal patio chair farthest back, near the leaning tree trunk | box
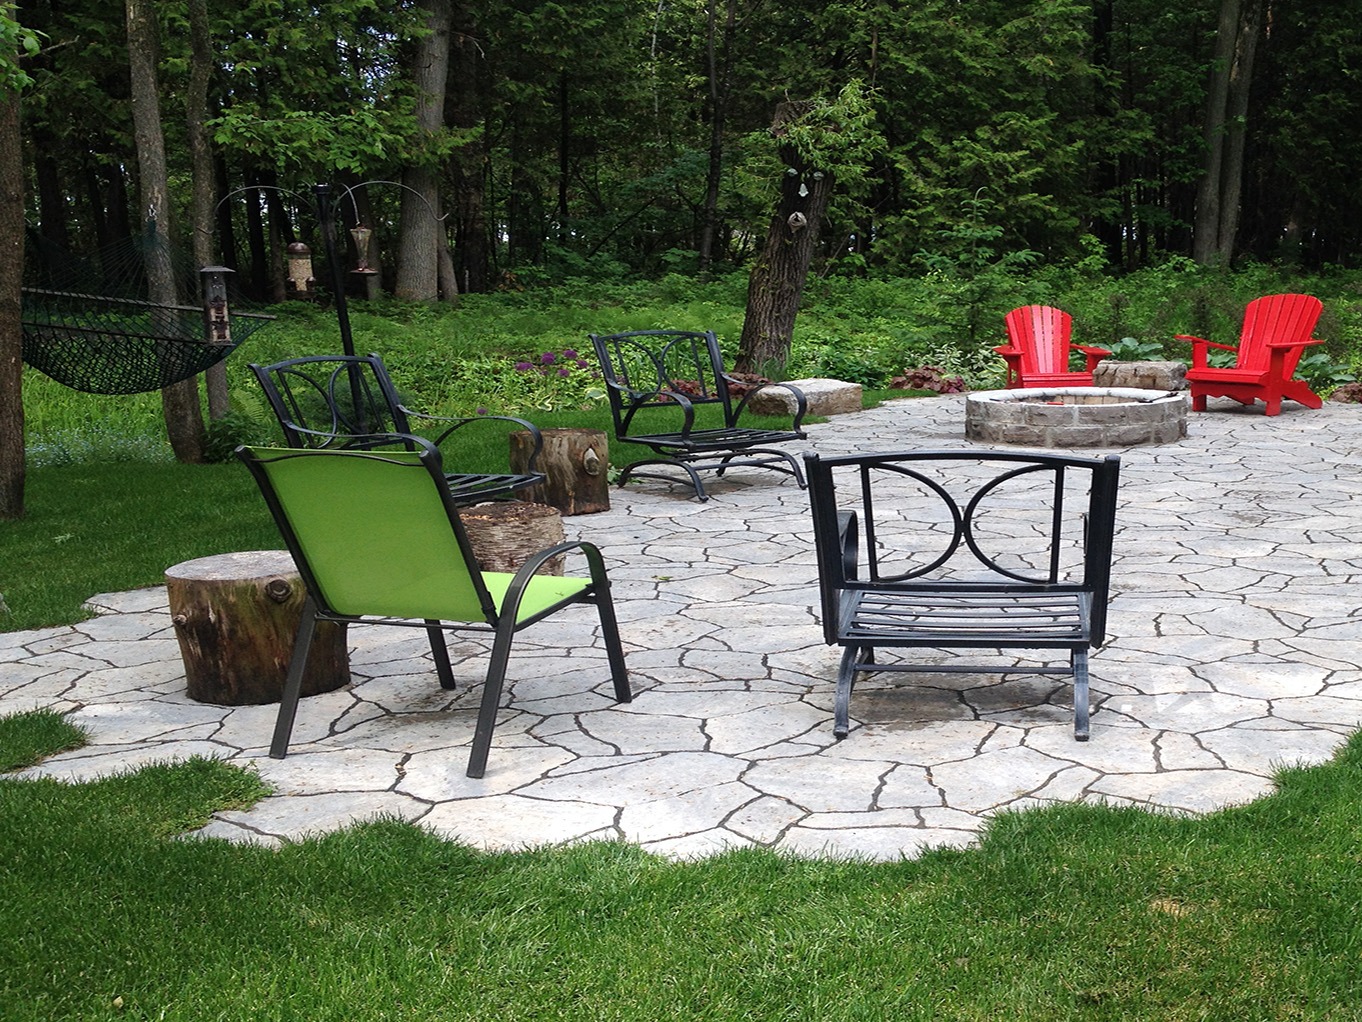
[591,330,806,500]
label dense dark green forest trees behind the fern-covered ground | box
[11,0,1362,307]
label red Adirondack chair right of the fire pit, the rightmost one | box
[1177,294,1324,416]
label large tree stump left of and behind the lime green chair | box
[166,551,350,706]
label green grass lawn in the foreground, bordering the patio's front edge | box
[8,718,1362,1022]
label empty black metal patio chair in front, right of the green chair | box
[805,451,1121,741]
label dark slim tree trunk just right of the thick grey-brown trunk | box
[445,0,492,293]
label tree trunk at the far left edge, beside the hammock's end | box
[0,89,25,518]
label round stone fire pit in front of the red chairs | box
[964,387,1188,447]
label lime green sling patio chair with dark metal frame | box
[237,437,632,777]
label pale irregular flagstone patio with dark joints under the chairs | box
[8,395,1362,858]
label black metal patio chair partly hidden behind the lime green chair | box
[251,354,543,504]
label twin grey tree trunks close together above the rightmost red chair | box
[1192,0,1263,266]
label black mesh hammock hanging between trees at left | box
[23,288,274,394]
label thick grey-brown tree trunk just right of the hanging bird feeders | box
[394,0,455,301]
